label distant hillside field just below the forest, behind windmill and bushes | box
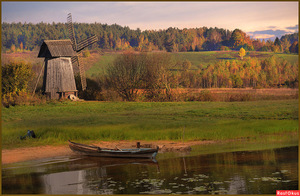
[1,50,298,78]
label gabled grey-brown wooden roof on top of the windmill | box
[38,39,76,58]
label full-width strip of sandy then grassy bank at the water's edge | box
[2,132,299,164]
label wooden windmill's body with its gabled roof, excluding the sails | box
[38,40,78,99]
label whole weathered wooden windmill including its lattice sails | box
[38,14,98,99]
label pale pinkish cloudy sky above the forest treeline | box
[1,1,299,39]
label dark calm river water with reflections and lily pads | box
[2,142,298,194]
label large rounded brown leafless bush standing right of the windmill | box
[107,52,173,101]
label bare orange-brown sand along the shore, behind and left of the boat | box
[2,141,215,164]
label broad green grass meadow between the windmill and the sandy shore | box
[2,100,298,149]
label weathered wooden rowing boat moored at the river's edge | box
[69,140,158,159]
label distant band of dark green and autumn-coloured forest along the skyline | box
[2,22,298,53]
